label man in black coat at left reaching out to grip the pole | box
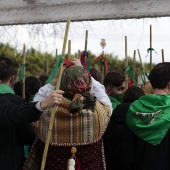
[0,57,63,170]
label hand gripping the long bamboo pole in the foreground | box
[40,90,64,110]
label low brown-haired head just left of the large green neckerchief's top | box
[122,86,145,103]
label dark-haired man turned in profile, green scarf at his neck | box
[103,72,125,110]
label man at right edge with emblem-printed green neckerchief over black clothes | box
[126,62,170,170]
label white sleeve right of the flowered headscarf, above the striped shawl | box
[90,77,113,114]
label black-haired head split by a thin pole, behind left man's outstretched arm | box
[14,76,41,101]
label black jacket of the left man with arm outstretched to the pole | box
[0,94,41,170]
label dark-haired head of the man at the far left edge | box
[0,57,17,87]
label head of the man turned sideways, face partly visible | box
[103,72,125,97]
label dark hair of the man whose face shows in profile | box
[103,71,125,87]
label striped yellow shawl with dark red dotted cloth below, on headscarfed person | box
[23,98,110,170]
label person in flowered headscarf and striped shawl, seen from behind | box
[24,66,111,170]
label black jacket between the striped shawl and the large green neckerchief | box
[103,103,131,170]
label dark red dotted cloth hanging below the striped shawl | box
[36,139,103,170]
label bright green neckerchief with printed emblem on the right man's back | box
[126,94,170,145]
